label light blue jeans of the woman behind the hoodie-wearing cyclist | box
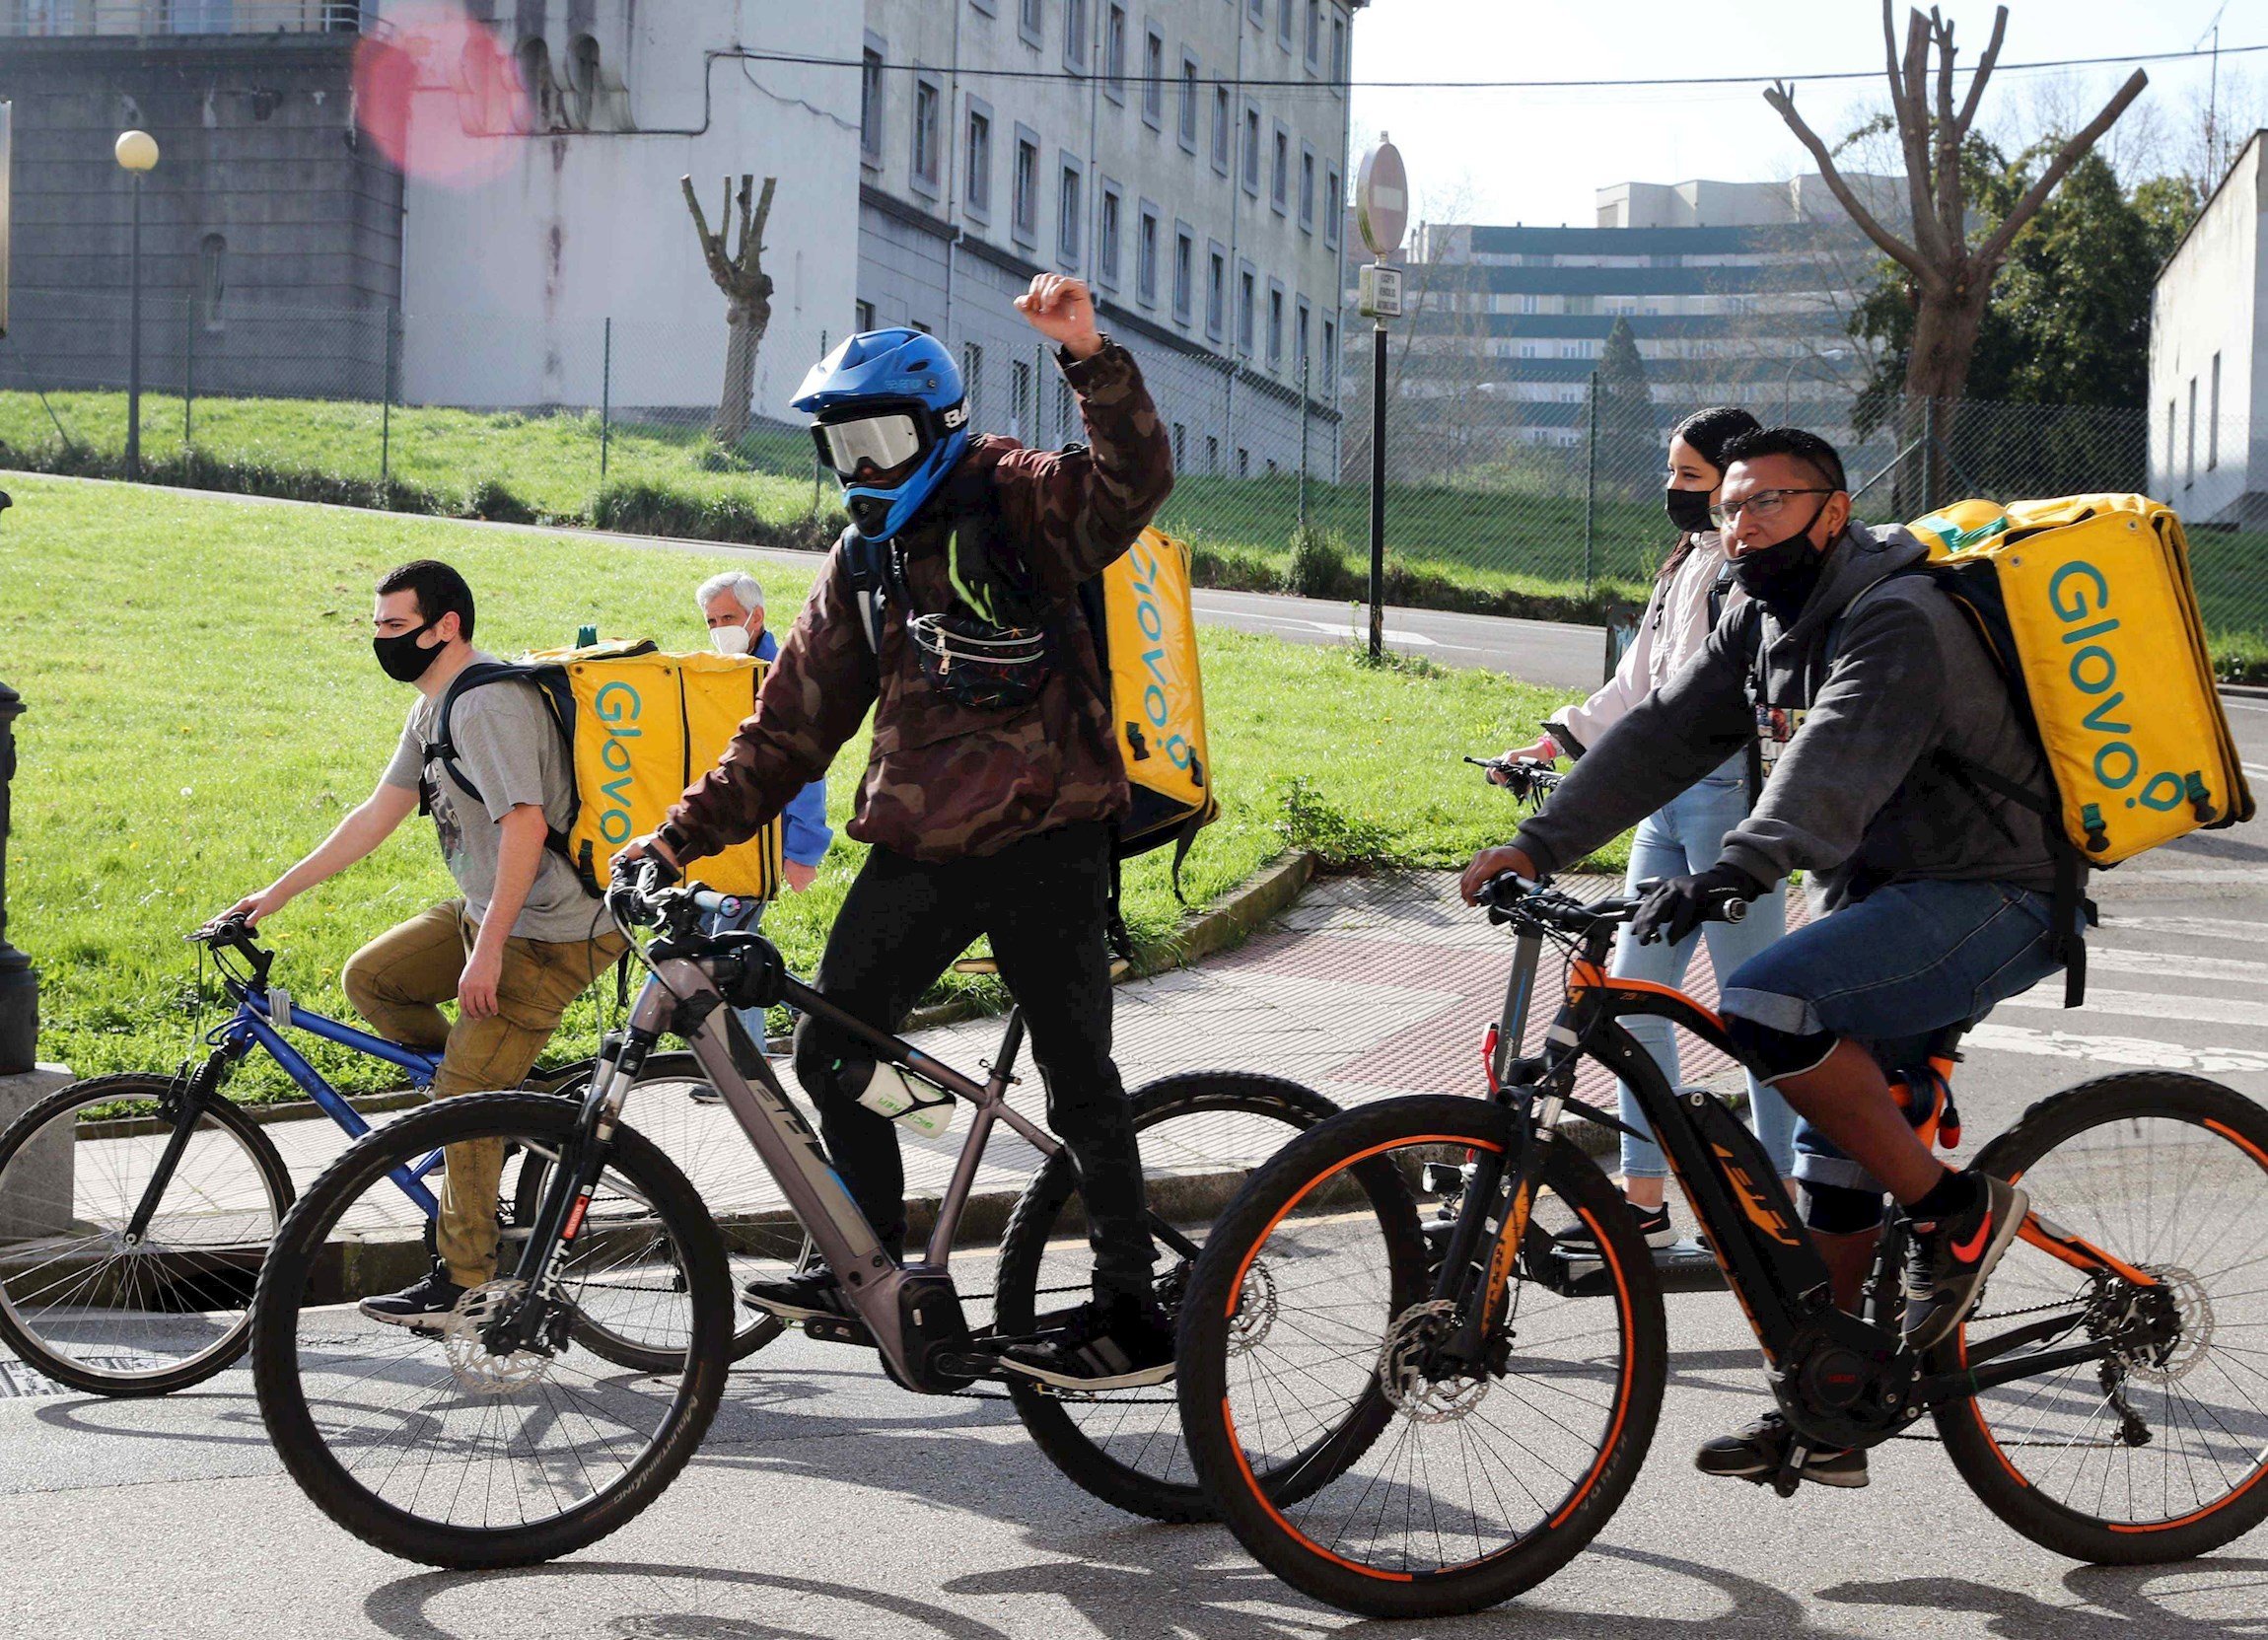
[1610,753,1797,1179]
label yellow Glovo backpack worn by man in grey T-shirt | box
[426,640,780,900]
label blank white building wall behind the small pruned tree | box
[372,0,860,417]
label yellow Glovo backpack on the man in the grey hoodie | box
[1907,494,2252,1005]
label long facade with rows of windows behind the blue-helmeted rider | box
[857,0,1363,474]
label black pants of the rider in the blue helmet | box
[796,821,1157,1298]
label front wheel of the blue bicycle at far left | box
[0,1073,293,1397]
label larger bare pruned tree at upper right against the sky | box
[1764,0,2150,417]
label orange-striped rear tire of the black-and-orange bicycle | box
[1930,1071,2268,1565]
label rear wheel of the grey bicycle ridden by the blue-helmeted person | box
[993,1071,1338,1520]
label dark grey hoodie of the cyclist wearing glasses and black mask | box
[1513,527,2055,909]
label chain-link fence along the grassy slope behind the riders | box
[0,290,2268,670]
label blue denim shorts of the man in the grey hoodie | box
[1724,883,2062,1191]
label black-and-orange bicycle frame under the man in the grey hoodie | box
[1478,930,2157,1463]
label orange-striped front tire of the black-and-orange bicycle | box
[1179,1096,1667,1619]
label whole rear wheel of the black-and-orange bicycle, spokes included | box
[1930,1071,2268,1565]
